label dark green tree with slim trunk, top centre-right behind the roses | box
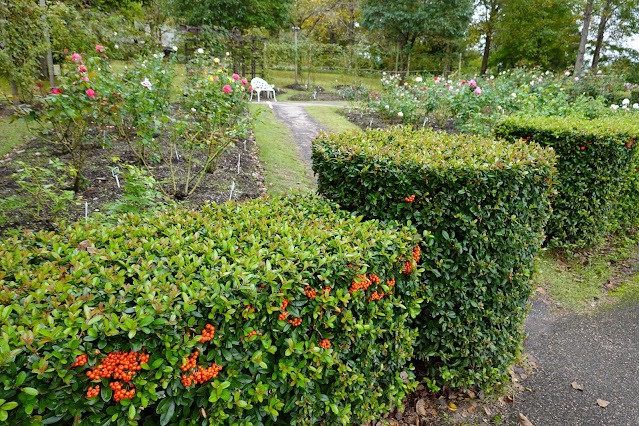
[361,0,473,72]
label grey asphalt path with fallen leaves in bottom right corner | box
[508,300,639,426]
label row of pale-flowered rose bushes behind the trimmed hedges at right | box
[364,69,623,135]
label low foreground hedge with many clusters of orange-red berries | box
[0,197,419,425]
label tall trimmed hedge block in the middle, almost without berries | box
[313,127,555,388]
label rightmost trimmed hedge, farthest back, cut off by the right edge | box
[495,114,639,248]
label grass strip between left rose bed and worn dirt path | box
[250,104,314,194]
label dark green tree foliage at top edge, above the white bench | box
[172,0,293,31]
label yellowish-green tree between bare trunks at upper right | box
[490,0,579,69]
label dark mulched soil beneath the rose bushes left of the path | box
[0,111,266,235]
